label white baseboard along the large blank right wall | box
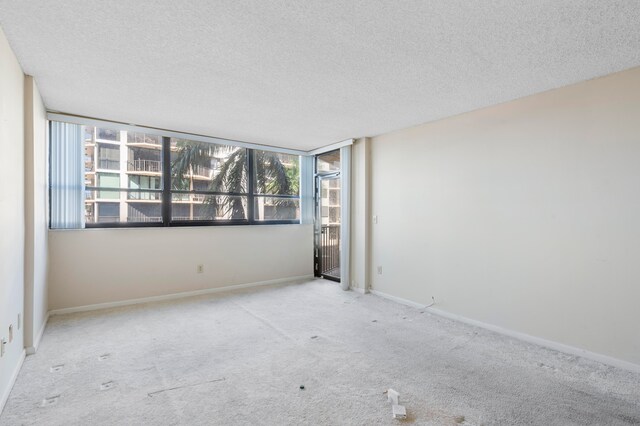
[371,290,640,373]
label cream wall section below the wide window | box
[49,225,313,310]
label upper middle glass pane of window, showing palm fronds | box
[171,138,247,193]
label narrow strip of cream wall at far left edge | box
[0,29,24,410]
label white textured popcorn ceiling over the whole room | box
[0,0,640,150]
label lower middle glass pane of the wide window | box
[171,194,247,220]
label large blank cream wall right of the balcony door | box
[370,68,640,364]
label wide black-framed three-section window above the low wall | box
[51,122,300,227]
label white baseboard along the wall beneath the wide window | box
[49,275,313,315]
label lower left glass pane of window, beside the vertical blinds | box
[85,189,162,223]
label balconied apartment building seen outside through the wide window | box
[84,126,300,223]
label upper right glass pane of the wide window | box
[254,150,300,195]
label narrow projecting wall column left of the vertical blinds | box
[24,76,48,352]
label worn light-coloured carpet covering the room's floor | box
[0,280,640,425]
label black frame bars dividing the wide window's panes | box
[76,136,302,229]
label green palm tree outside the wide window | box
[171,139,299,219]
